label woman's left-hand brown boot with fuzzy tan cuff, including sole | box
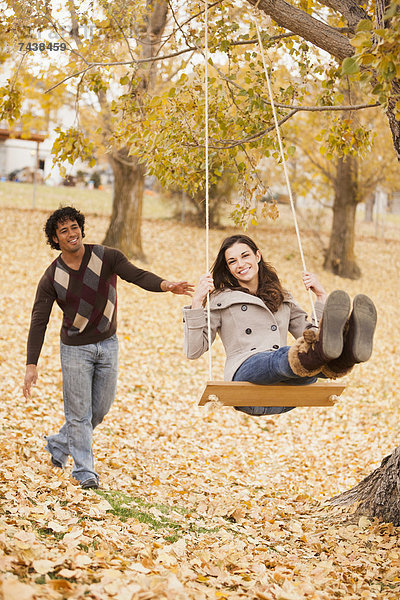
[288,290,351,377]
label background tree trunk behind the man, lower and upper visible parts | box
[103,0,168,260]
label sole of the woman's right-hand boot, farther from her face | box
[351,294,377,363]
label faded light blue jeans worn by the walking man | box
[46,334,118,482]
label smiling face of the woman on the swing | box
[225,242,261,292]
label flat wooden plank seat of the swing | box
[199,381,345,406]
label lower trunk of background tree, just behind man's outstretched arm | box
[103,148,145,260]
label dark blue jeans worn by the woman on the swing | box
[233,346,317,417]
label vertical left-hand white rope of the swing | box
[204,0,213,381]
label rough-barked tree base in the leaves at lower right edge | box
[329,446,400,527]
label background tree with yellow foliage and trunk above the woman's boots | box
[287,86,400,279]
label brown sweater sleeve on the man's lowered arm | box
[26,271,56,365]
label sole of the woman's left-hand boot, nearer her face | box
[322,290,351,362]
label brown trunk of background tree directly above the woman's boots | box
[324,156,361,279]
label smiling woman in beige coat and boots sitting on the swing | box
[183,235,376,416]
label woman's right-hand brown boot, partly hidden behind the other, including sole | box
[321,294,377,378]
